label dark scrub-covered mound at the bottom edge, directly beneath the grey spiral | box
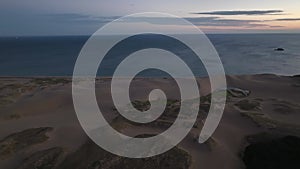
[57,140,191,169]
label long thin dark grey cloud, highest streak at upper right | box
[193,10,284,15]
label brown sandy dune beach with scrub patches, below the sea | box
[0,74,300,169]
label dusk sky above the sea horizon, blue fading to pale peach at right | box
[0,0,300,36]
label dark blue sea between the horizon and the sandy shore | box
[0,34,300,76]
